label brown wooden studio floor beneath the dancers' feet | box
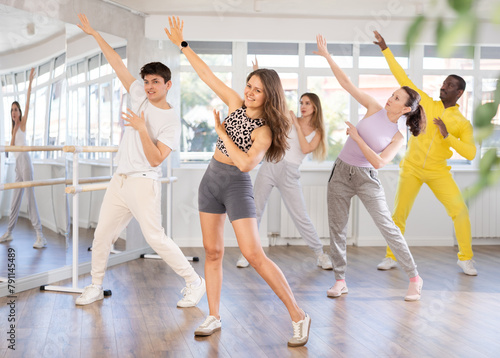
[0,246,500,358]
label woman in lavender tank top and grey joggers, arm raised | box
[315,35,425,301]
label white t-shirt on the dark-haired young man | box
[116,80,181,179]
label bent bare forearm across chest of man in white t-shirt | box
[122,109,172,167]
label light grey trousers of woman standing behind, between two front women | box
[253,160,323,255]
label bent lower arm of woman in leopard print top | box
[214,109,272,172]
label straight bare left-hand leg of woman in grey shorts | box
[200,212,226,319]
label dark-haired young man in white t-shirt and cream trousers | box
[76,14,206,307]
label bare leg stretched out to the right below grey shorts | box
[235,218,305,322]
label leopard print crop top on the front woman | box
[216,107,265,157]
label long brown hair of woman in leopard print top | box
[247,68,291,162]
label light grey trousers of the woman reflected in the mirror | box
[7,153,42,234]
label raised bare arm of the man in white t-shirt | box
[77,14,135,92]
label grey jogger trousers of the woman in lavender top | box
[328,159,418,280]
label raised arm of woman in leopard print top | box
[165,17,243,113]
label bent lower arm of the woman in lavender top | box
[346,122,404,169]
